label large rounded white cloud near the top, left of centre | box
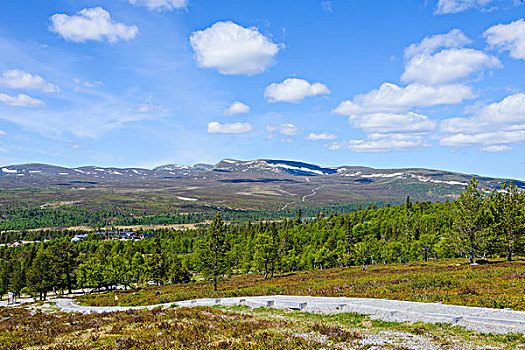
[190,22,280,75]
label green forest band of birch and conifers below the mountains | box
[0,178,525,299]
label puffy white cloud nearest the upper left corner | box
[49,7,139,43]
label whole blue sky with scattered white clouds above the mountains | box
[0,0,525,179]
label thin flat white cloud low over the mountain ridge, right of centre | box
[326,134,429,152]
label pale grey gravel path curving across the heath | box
[47,295,525,333]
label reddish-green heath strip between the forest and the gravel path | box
[78,260,525,311]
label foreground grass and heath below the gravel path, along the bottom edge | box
[0,307,525,350]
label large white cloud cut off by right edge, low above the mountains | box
[439,93,525,152]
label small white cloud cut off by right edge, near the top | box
[483,18,525,60]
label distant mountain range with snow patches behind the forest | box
[0,159,525,212]
